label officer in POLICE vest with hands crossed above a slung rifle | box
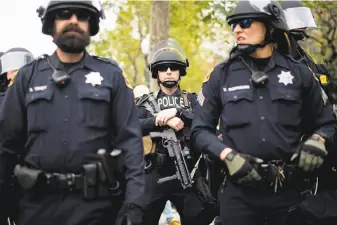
[138,40,213,225]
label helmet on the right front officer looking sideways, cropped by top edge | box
[227,0,288,30]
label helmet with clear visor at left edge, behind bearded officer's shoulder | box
[0,48,34,75]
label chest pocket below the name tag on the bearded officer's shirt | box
[26,88,54,131]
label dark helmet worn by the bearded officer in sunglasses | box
[37,0,105,36]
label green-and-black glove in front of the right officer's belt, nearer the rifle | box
[224,150,263,184]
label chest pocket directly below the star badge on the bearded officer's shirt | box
[78,87,111,128]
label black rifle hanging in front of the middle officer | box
[150,128,193,189]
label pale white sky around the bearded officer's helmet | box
[0,0,113,57]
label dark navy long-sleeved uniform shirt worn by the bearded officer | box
[0,53,144,206]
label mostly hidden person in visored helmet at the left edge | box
[0,47,34,105]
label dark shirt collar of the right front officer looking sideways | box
[231,50,289,72]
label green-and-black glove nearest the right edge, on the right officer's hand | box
[291,136,328,172]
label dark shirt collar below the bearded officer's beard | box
[39,51,99,72]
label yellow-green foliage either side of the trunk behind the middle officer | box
[90,1,228,92]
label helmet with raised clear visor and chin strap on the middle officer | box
[148,39,189,87]
